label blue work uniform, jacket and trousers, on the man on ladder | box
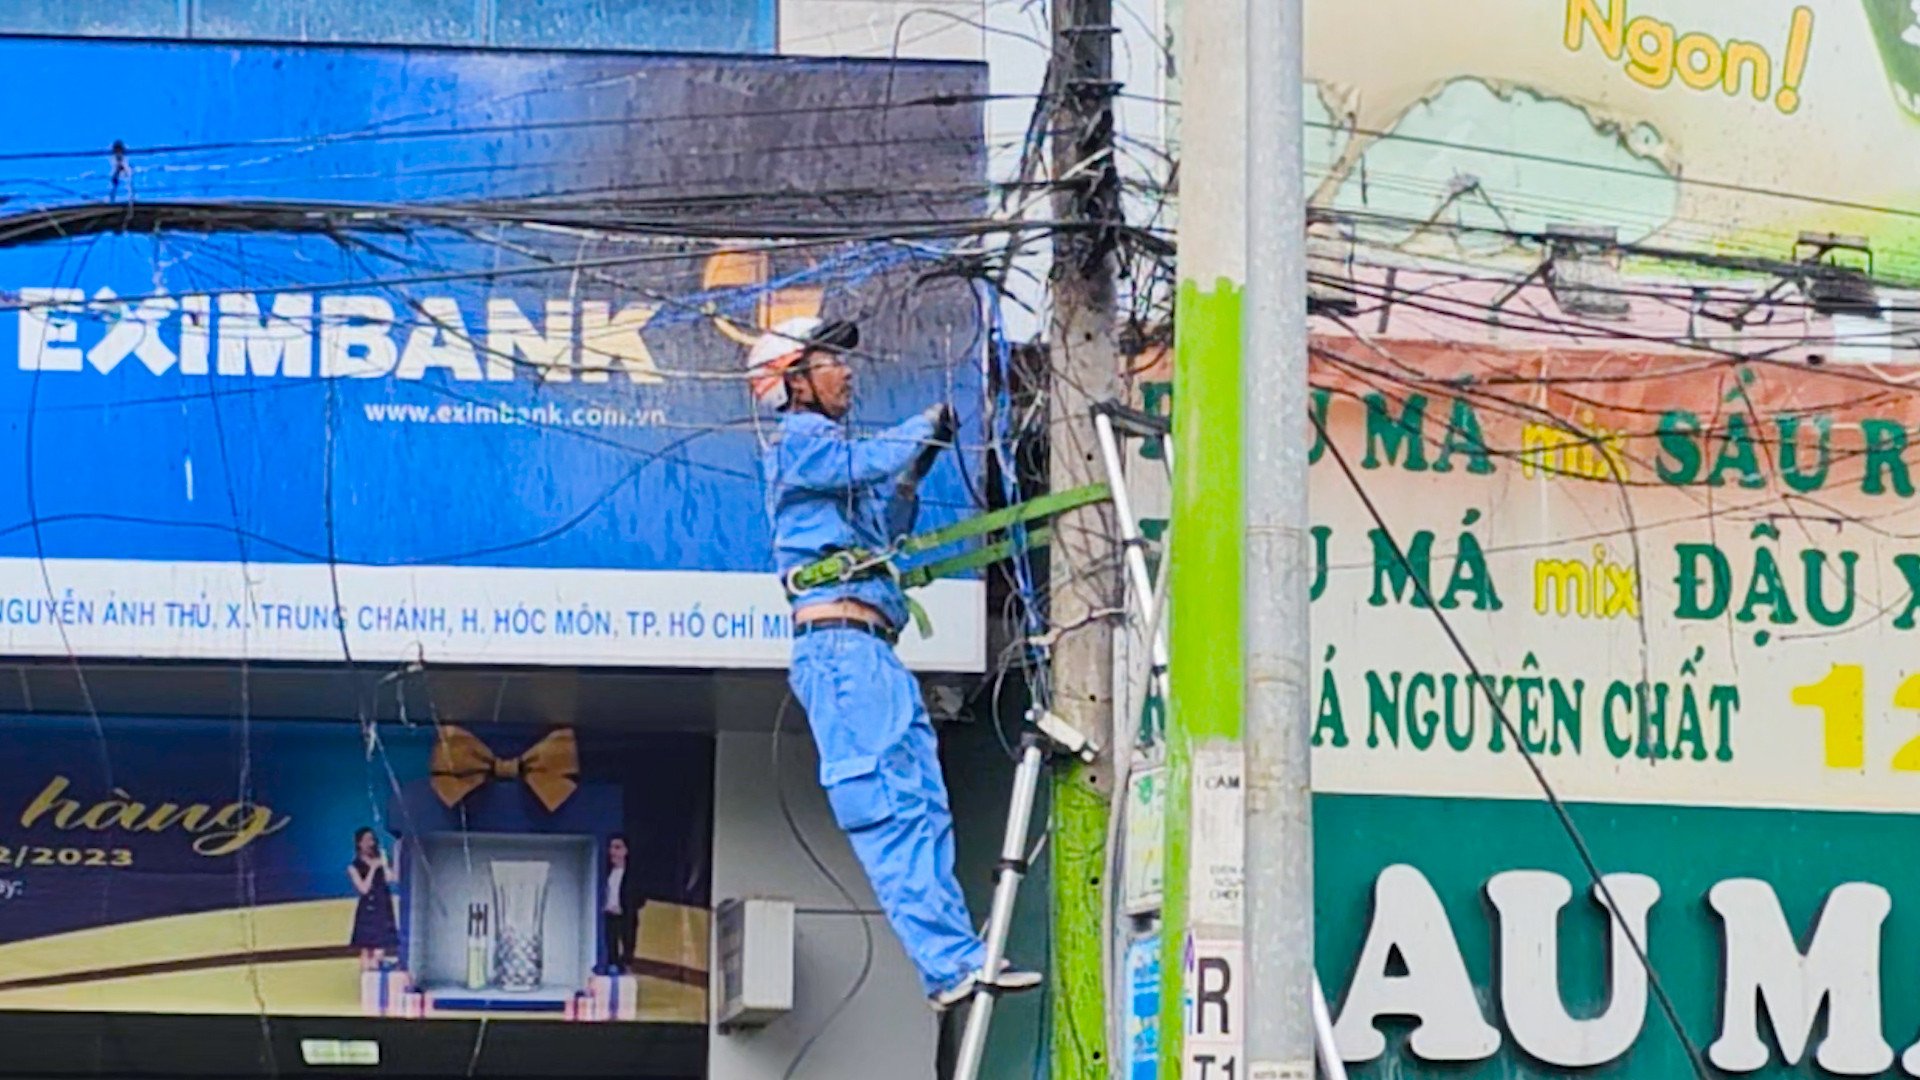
[764,411,987,995]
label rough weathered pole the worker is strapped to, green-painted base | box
[1046,0,1123,1080]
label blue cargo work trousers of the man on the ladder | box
[789,630,987,995]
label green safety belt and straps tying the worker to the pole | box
[785,484,1112,638]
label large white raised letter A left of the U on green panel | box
[1332,865,1500,1061]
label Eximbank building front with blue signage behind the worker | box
[0,0,1082,1078]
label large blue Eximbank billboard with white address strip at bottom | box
[0,38,987,671]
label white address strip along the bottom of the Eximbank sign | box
[0,557,987,671]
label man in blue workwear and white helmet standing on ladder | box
[747,317,1041,1011]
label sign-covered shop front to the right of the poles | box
[1113,0,1920,1080]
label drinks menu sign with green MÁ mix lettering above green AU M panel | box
[1135,336,1920,1080]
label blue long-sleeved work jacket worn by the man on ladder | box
[764,411,933,630]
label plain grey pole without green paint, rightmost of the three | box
[1240,0,1315,1080]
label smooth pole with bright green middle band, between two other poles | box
[1160,0,1251,1080]
